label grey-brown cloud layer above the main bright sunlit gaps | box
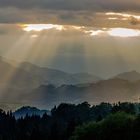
[0,0,140,29]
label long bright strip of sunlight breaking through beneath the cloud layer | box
[20,23,140,38]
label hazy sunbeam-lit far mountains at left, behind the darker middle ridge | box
[0,57,101,109]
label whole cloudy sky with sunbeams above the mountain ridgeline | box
[0,0,140,78]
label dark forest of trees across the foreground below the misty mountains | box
[0,102,140,140]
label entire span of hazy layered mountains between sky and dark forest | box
[0,58,140,108]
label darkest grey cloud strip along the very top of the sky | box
[0,0,140,11]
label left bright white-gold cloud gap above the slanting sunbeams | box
[21,24,64,32]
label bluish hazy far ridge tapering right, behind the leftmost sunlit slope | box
[19,62,101,86]
